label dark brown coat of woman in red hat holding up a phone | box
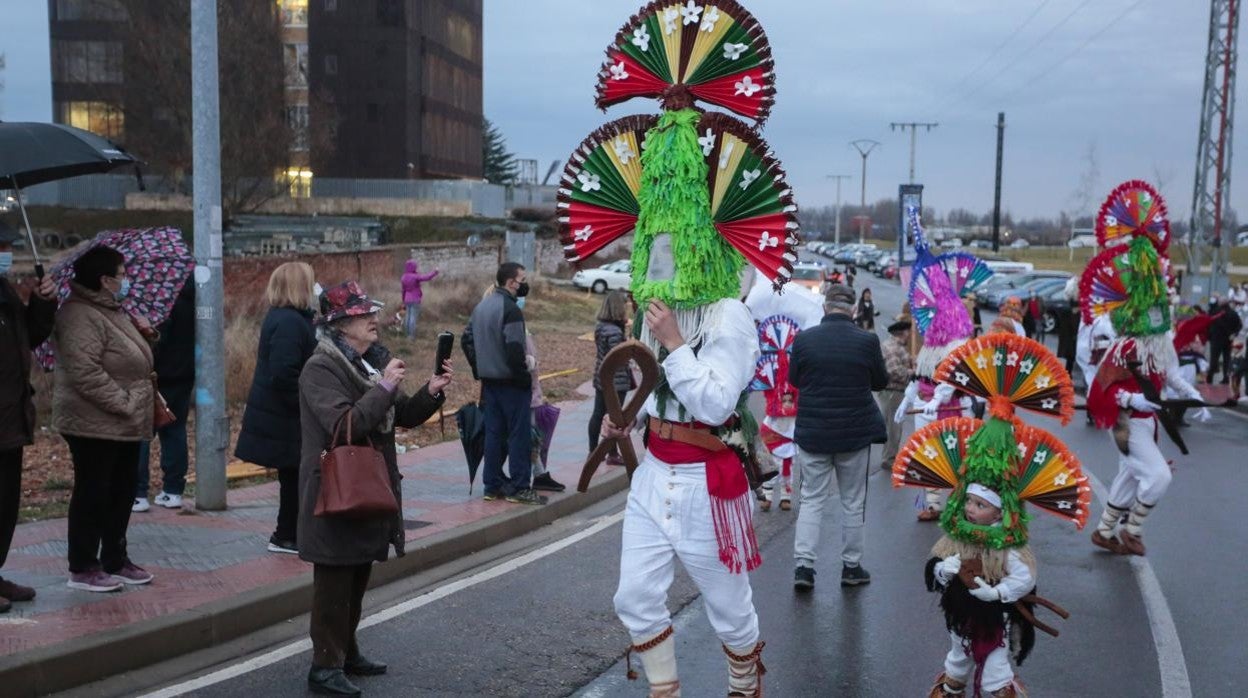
[297,342,444,566]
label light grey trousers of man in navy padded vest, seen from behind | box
[792,446,871,567]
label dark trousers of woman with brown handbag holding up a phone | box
[308,563,373,669]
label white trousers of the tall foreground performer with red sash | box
[615,453,759,648]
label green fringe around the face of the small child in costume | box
[940,417,1031,551]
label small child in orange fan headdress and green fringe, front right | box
[892,332,1091,698]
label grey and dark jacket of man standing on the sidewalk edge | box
[459,288,533,390]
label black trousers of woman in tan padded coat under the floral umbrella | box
[65,435,139,574]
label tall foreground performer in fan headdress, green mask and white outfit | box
[557,0,797,697]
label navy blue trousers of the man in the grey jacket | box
[482,382,533,494]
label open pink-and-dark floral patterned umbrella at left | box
[35,227,195,371]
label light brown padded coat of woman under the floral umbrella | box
[52,282,154,441]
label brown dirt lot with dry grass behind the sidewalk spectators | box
[21,280,602,521]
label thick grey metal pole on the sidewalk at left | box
[191,0,230,511]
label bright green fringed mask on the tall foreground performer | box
[631,109,745,310]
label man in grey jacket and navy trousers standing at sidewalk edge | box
[459,262,547,504]
